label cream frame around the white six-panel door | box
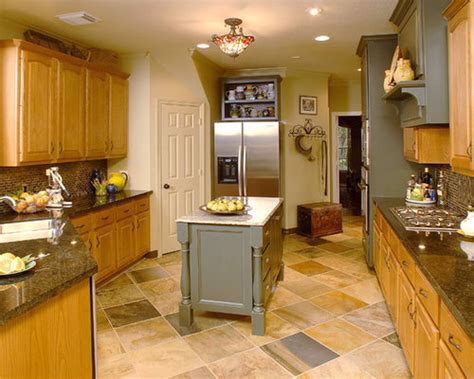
[156,100,209,256]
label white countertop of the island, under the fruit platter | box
[176,196,283,226]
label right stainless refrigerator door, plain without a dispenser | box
[242,121,280,197]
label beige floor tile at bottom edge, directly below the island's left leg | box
[129,339,204,378]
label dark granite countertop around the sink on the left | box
[0,191,151,325]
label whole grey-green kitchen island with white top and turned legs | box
[176,197,284,335]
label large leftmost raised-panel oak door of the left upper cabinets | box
[19,50,57,163]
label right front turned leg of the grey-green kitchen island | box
[252,247,265,336]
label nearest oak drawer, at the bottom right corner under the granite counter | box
[440,303,474,375]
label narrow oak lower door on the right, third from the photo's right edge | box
[398,270,415,372]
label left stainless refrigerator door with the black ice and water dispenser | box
[214,122,243,197]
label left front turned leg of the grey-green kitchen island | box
[178,223,193,326]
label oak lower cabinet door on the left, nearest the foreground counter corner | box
[93,224,117,281]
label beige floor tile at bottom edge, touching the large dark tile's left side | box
[209,349,292,379]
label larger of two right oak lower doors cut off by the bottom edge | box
[414,297,439,379]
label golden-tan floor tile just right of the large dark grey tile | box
[305,319,375,355]
